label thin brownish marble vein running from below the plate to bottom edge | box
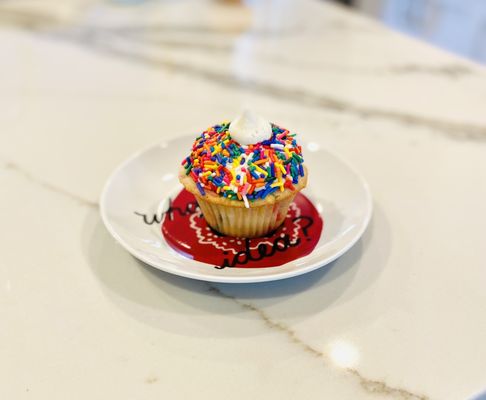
[208,284,429,400]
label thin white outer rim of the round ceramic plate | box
[99,138,373,283]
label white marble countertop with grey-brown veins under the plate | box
[0,0,486,400]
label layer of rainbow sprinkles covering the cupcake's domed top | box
[182,122,304,208]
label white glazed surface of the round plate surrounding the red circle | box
[100,136,372,283]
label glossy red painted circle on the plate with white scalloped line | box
[162,190,323,269]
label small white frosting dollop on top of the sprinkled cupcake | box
[228,110,272,145]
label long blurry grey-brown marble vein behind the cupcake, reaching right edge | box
[59,31,486,141]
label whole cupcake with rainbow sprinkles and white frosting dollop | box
[179,111,308,238]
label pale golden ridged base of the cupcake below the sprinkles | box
[196,192,297,238]
